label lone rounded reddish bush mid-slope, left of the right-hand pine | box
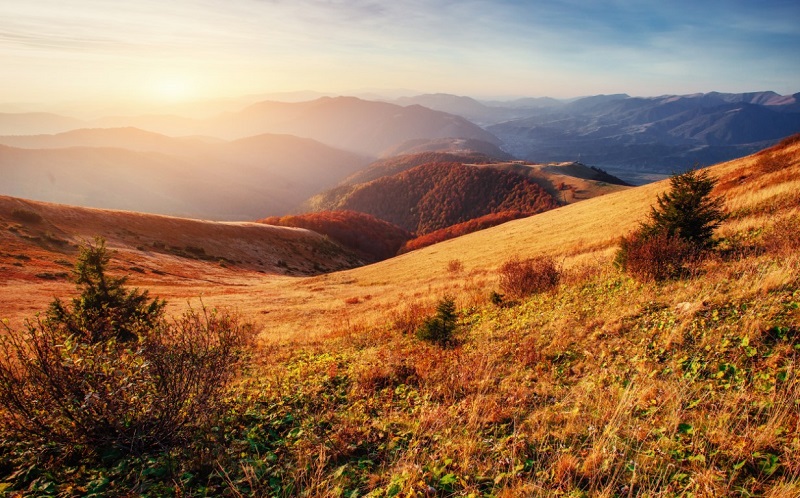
[499,256,561,298]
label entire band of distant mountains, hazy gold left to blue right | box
[0,92,800,220]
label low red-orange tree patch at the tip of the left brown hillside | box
[260,211,411,261]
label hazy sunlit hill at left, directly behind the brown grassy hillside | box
[0,128,368,220]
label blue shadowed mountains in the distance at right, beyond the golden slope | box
[398,91,800,183]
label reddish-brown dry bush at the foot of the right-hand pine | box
[615,232,700,281]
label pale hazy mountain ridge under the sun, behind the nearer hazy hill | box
[0,97,501,157]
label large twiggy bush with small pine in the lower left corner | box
[0,237,254,458]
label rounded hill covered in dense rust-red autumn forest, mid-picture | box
[341,163,558,235]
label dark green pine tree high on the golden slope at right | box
[642,170,726,249]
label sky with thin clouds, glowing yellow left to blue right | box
[0,0,800,112]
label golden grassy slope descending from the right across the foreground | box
[1,138,800,497]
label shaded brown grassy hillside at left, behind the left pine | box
[0,196,364,318]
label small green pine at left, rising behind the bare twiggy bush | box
[47,237,166,343]
